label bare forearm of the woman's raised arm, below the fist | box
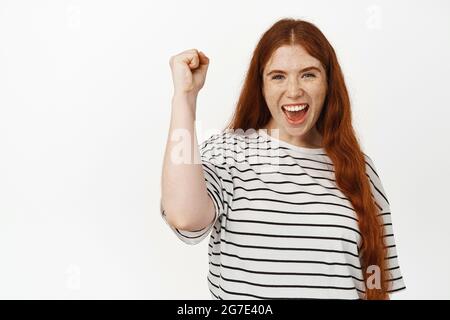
[161,94,214,230]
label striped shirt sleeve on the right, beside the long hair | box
[365,155,406,293]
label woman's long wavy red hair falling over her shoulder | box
[227,19,388,299]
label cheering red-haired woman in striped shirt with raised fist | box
[161,19,405,299]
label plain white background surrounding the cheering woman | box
[0,0,450,299]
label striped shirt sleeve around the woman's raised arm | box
[160,135,232,245]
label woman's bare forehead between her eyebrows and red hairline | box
[265,45,323,70]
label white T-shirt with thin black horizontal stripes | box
[161,130,405,299]
